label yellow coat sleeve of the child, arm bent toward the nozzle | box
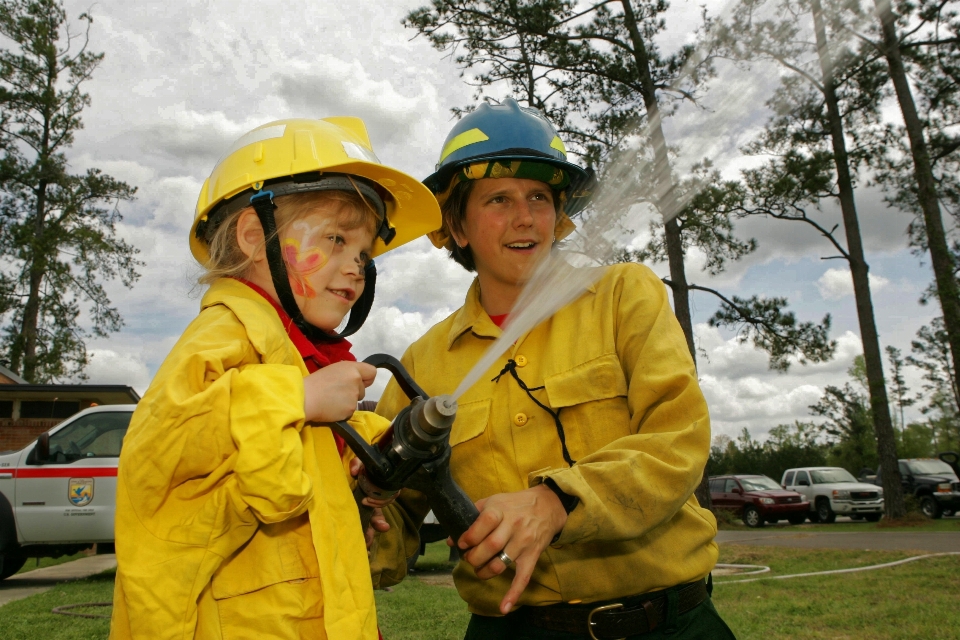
[119,306,312,553]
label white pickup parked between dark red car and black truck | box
[780,467,883,523]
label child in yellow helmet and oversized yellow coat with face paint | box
[111,118,440,639]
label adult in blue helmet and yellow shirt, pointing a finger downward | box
[374,98,733,640]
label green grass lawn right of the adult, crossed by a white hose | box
[713,545,960,640]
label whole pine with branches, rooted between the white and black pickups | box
[714,0,906,518]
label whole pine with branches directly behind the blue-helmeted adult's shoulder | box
[404,0,835,506]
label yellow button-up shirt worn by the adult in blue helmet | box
[373,264,717,616]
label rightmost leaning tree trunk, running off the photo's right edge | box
[874,0,960,396]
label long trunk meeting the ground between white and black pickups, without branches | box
[811,0,906,519]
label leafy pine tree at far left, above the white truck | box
[0,0,140,383]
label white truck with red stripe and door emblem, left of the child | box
[0,404,136,580]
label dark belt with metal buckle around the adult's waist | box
[521,580,709,640]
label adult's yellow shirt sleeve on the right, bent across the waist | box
[534,265,710,545]
